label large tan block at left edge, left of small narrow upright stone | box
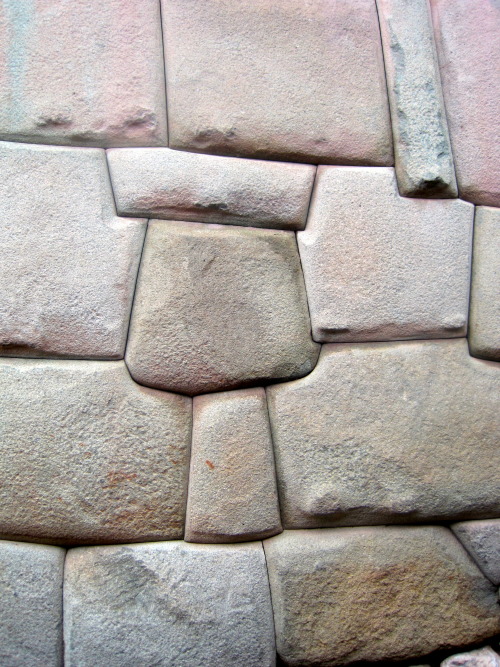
[0,359,191,544]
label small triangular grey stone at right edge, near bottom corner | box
[451,519,500,584]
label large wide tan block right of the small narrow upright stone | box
[268,340,500,528]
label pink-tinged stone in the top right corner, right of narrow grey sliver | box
[431,0,500,206]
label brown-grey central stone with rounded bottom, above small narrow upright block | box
[126,220,318,395]
